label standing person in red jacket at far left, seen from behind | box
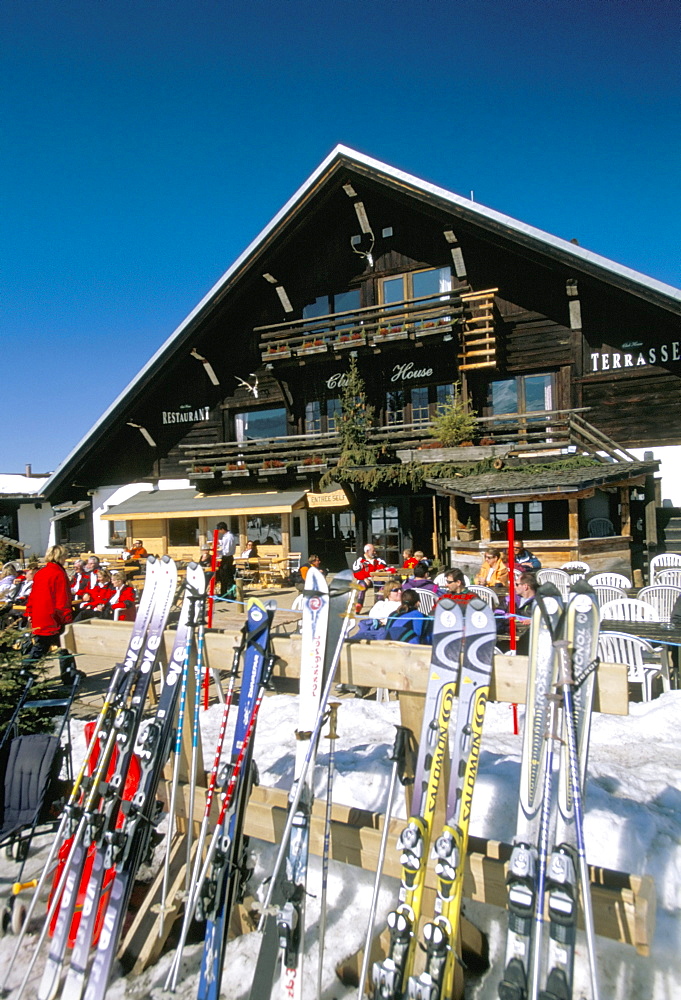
[26,545,73,660]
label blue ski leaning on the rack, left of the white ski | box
[197,600,273,1000]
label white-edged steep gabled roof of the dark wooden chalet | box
[44,145,681,497]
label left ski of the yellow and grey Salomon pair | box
[372,598,464,1000]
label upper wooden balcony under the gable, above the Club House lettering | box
[254,288,497,370]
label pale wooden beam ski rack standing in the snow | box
[63,621,656,979]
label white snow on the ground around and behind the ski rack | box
[0,692,681,1000]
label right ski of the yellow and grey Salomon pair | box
[407,598,497,1000]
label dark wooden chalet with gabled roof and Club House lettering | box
[44,146,681,568]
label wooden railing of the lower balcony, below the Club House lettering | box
[180,408,635,480]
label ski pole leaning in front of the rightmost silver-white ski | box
[554,639,599,1000]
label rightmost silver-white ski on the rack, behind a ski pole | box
[538,580,599,1000]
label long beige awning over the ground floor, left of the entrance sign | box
[101,489,307,521]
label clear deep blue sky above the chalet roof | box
[0,0,681,472]
